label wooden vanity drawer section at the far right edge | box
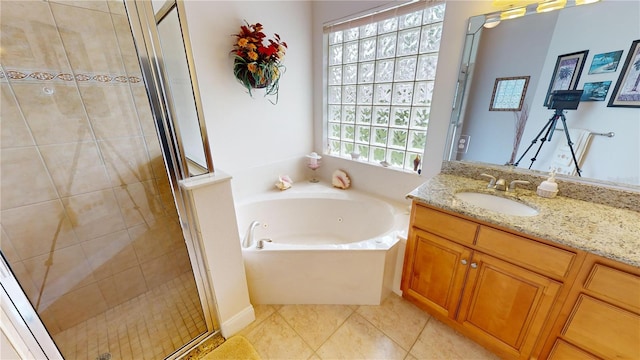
[542,254,640,360]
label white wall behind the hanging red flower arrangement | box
[185,0,313,192]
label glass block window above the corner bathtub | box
[322,1,446,173]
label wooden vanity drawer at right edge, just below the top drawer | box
[562,294,640,359]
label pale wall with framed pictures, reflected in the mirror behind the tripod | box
[520,0,640,184]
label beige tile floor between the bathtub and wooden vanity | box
[235,294,498,360]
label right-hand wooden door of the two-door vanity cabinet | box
[457,252,561,357]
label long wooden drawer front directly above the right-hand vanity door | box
[476,226,576,278]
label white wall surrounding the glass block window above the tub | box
[313,1,492,200]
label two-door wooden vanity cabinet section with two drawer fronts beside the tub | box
[401,202,581,358]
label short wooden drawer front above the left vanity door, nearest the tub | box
[413,204,478,244]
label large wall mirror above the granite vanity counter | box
[445,0,640,189]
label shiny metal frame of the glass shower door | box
[124,0,220,359]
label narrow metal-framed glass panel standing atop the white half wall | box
[130,0,214,179]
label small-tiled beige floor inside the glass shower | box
[53,273,206,360]
